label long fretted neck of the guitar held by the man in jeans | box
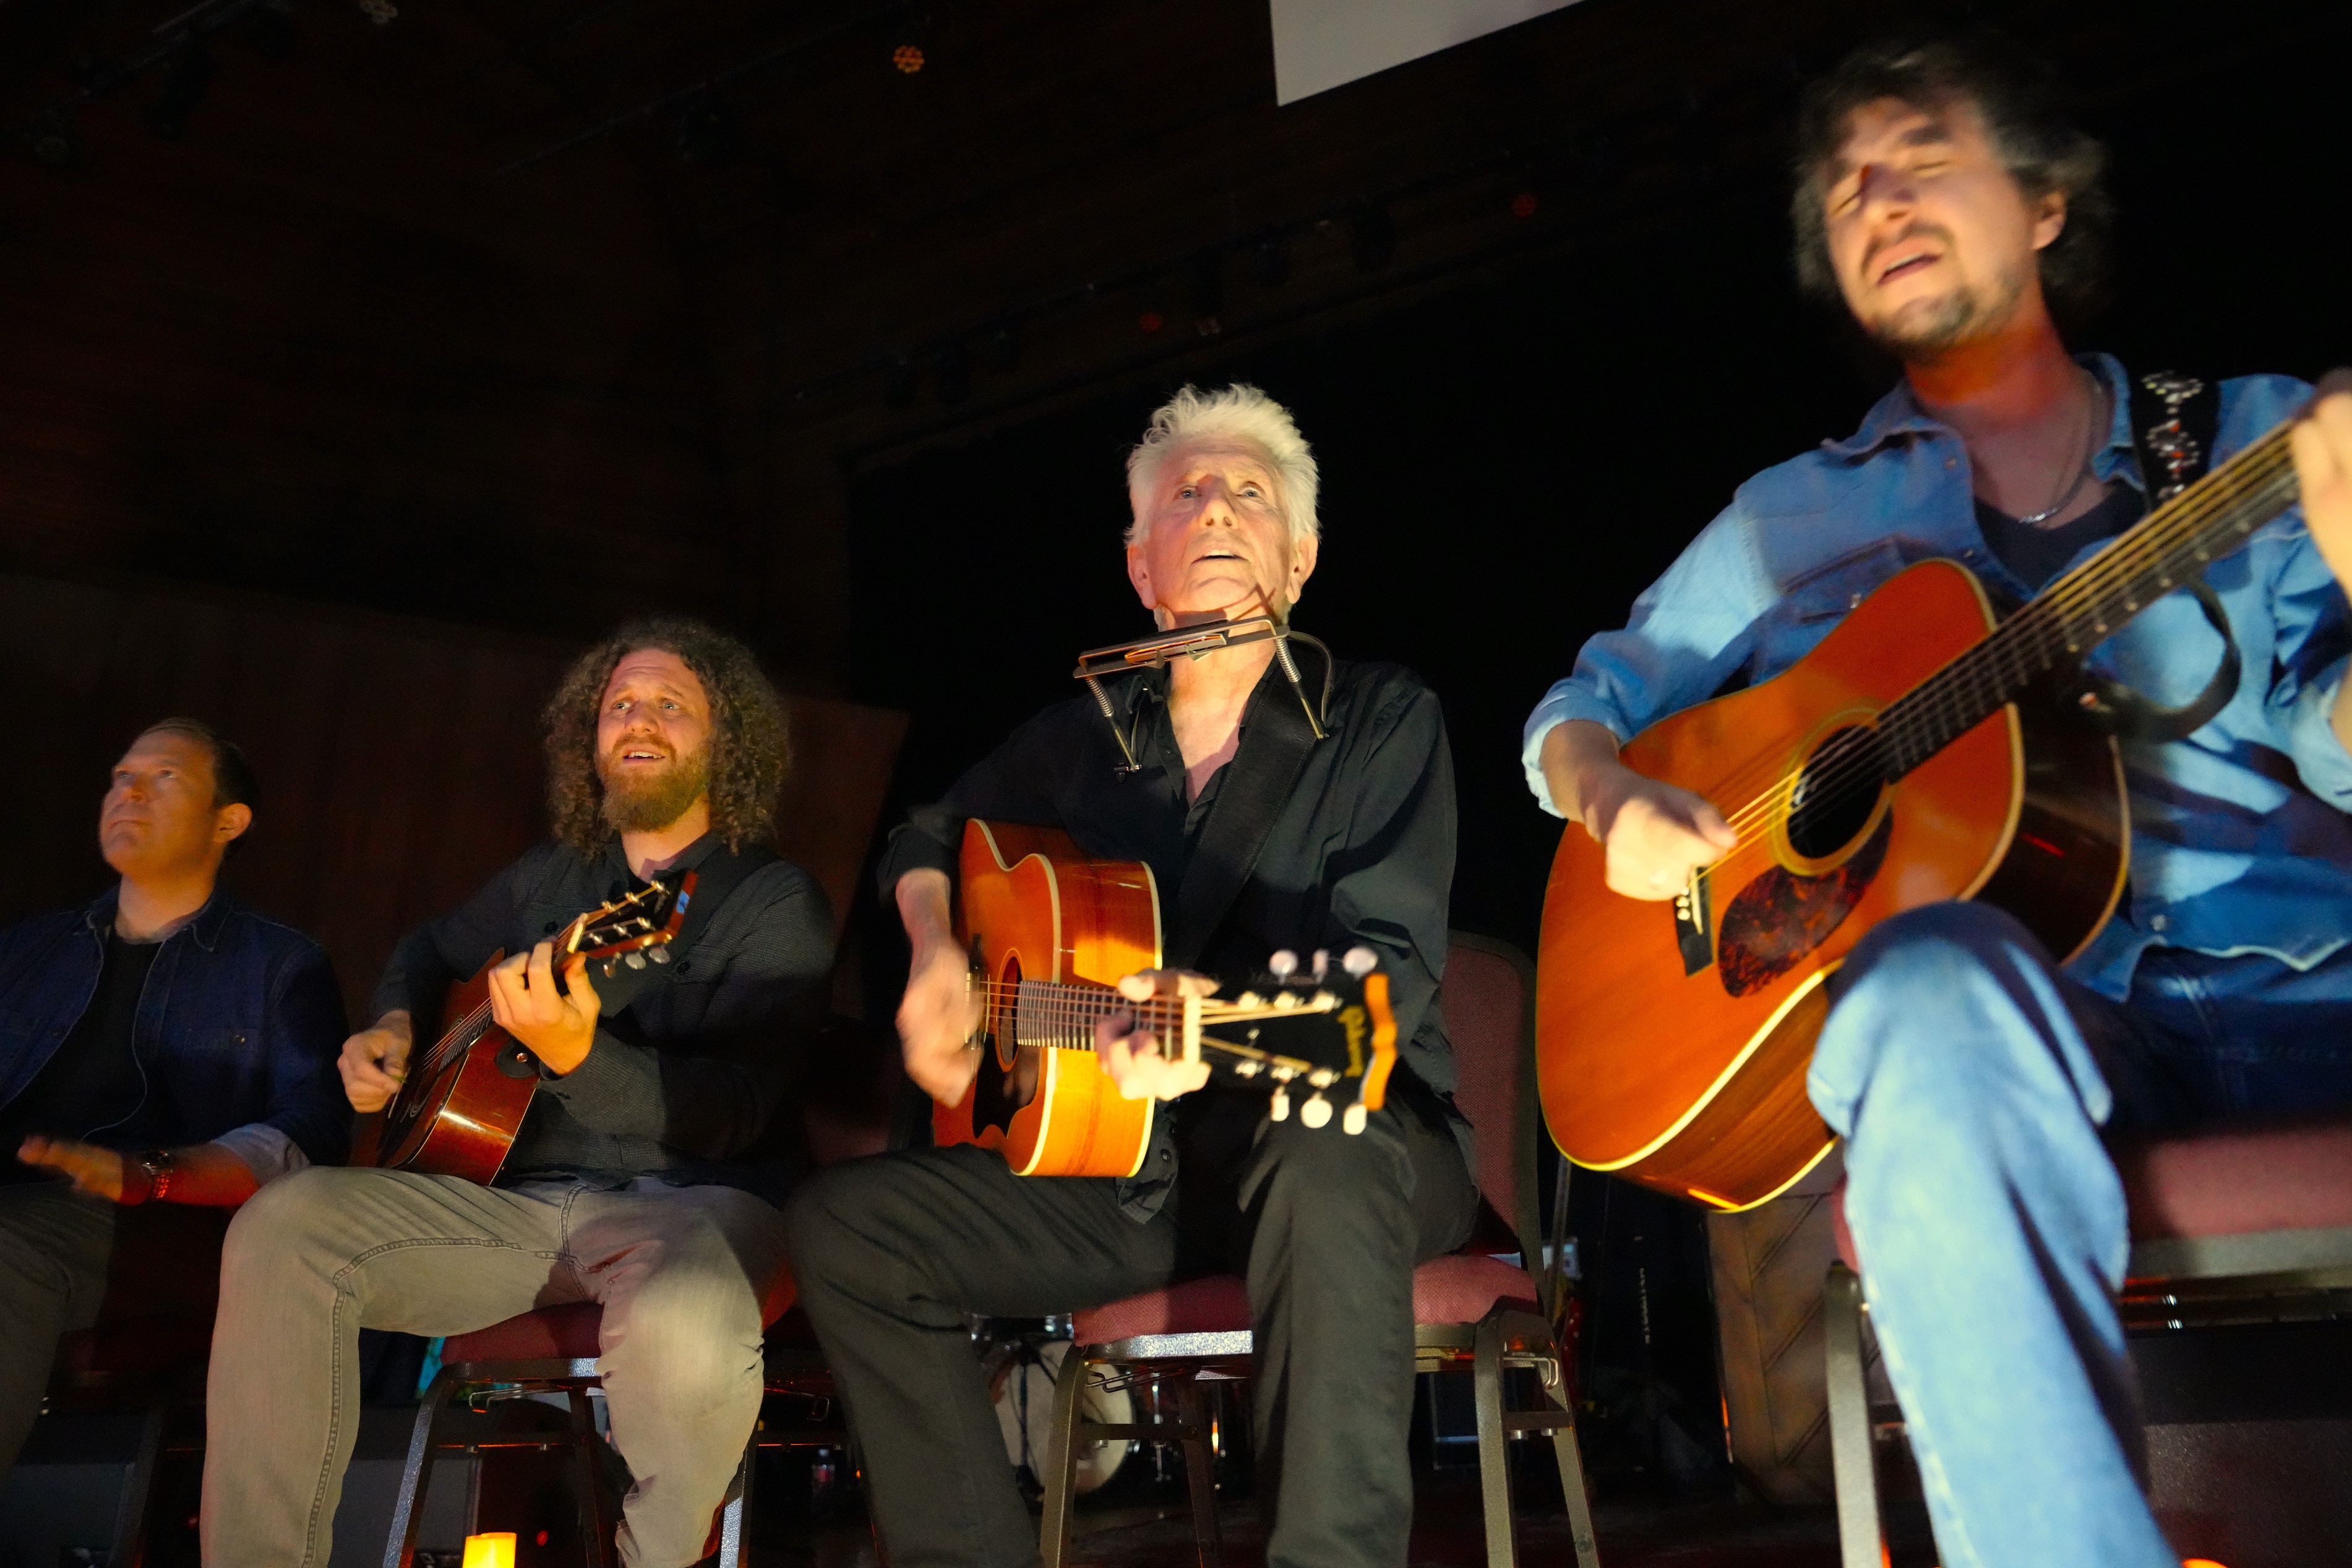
[1877,423,2296,783]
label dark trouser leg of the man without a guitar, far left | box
[0,1183,115,1474]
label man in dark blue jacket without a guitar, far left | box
[0,719,350,1472]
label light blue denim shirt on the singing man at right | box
[1524,355,2352,999]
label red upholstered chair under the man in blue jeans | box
[1825,1121,2352,1568]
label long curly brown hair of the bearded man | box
[541,616,792,858]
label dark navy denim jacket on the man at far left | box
[0,889,350,1175]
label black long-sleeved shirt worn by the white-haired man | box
[880,656,1470,1218]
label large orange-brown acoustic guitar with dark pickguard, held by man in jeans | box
[1536,413,2296,1210]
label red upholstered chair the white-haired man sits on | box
[1039,933,1599,1568]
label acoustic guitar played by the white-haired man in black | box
[932,820,1397,1175]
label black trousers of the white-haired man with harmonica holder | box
[786,1093,1477,1568]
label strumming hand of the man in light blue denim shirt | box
[1543,719,1738,901]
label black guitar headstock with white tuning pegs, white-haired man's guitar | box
[1200,948,1397,1133]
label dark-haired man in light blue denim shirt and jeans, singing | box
[1524,40,2352,1568]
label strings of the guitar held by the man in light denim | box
[1715,426,2293,865]
